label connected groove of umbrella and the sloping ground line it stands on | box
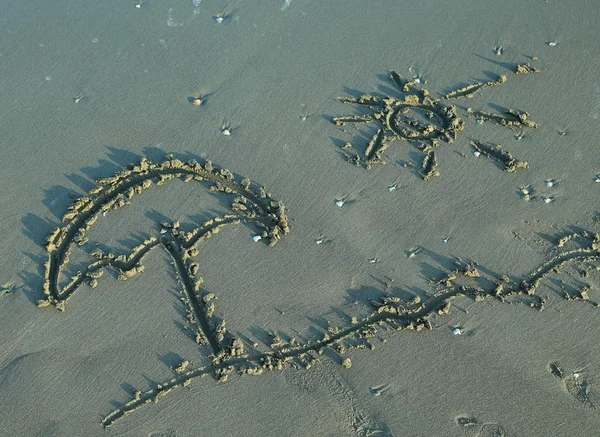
[39,157,600,427]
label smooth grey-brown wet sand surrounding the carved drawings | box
[0,0,600,437]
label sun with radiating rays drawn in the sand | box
[332,64,539,177]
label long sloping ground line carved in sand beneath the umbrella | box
[102,225,600,427]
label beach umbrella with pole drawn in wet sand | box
[38,157,289,355]
